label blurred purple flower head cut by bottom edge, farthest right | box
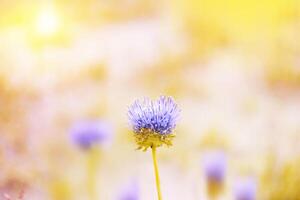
[234,178,256,200]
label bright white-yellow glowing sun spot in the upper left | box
[36,7,60,37]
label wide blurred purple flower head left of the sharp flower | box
[70,120,112,149]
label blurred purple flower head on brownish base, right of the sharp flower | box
[204,151,226,183]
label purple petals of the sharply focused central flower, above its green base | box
[128,96,180,135]
